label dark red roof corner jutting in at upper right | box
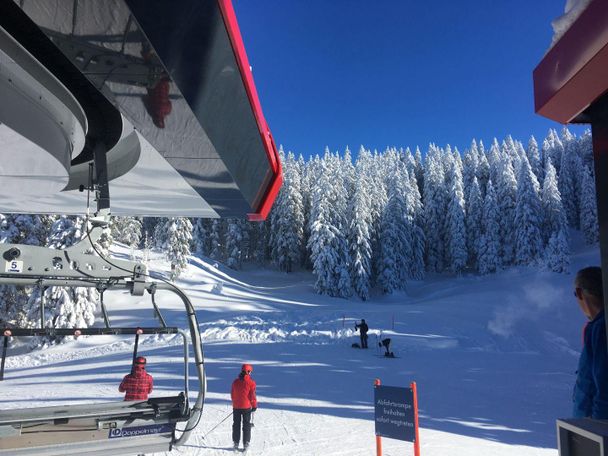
[534,0,608,124]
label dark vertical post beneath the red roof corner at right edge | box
[589,94,608,350]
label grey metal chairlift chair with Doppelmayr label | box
[0,220,206,455]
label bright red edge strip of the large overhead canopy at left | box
[217,0,283,221]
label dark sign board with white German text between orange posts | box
[374,385,416,442]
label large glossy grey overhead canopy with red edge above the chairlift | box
[0,0,281,220]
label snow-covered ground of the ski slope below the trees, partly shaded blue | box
[0,240,599,456]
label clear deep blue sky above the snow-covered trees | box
[233,0,582,156]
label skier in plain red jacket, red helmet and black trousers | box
[230,364,258,450]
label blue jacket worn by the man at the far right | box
[573,311,608,419]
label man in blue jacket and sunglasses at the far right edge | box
[572,266,608,420]
